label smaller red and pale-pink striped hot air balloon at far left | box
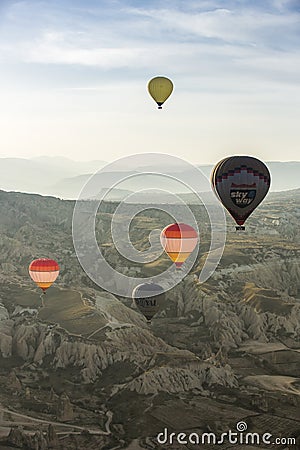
[29,258,59,294]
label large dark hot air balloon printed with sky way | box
[211,156,271,230]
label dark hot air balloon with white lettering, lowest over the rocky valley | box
[132,282,165,323]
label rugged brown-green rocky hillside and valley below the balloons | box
[0,188,300,449]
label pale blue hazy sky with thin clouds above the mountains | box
[0,0,300,163]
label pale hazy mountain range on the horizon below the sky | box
[0,156,300,201]
